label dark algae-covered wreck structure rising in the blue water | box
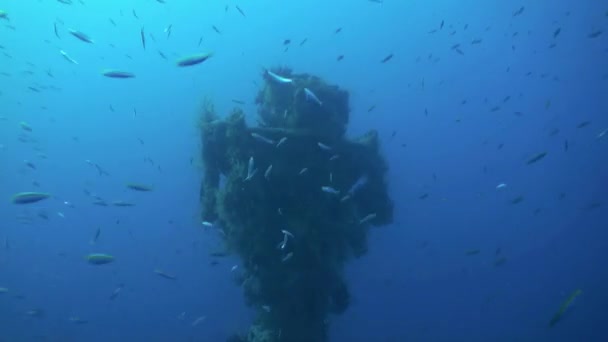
[201,68,393,342]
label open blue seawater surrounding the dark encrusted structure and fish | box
[0,0,608,341]
